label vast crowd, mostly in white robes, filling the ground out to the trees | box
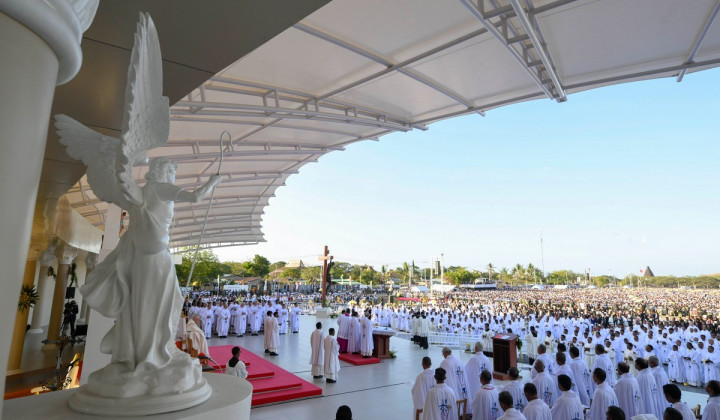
[177,288,720,419]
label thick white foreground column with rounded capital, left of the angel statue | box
[0,0,97,416]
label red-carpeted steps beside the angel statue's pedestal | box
[209,346,322,407]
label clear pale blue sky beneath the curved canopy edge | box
[215,69,720,277]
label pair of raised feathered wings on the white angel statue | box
[55,13,170,209]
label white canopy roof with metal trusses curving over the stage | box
[70,0,720,247]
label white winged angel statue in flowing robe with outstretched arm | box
[56,14,221,415]
